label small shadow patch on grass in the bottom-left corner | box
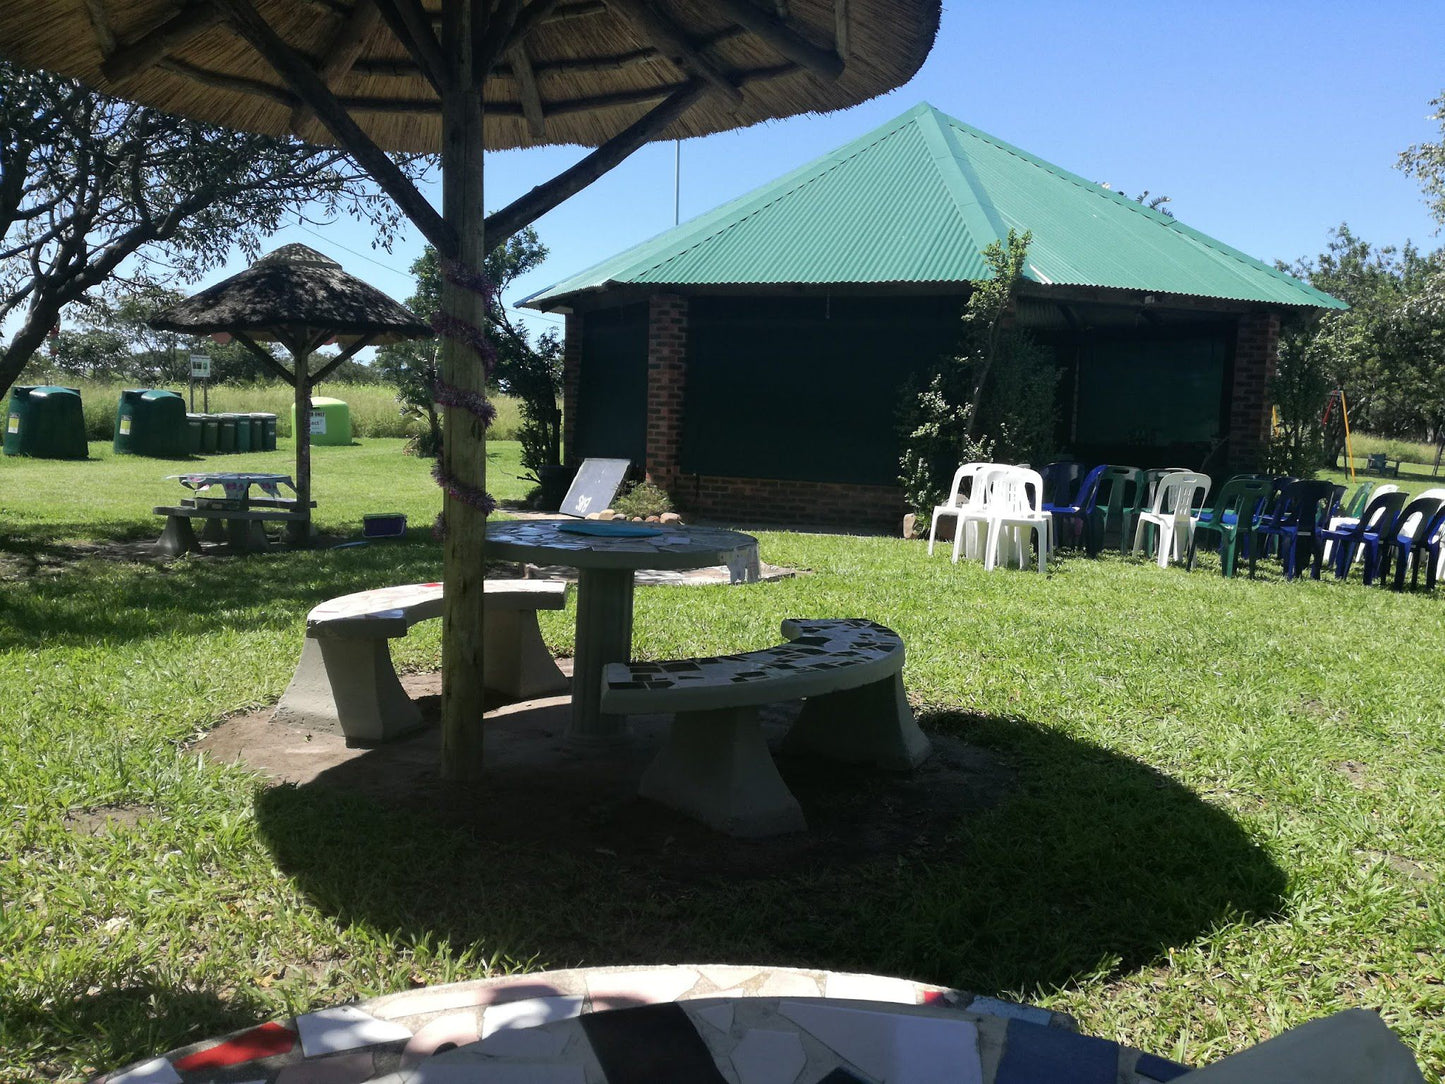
[0,977,266,1080]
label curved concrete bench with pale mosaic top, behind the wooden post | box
[276,580,568,744]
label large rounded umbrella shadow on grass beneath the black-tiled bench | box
[256,715,1285,993]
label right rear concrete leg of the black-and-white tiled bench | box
[779,674,932,772]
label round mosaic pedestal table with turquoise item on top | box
[487,519,757,744]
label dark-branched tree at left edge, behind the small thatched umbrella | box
[0,62,416,395]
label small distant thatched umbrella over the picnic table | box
[150,244,432,539]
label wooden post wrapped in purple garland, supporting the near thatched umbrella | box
[441,0,487,780]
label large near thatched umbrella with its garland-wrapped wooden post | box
[0,0,941,778]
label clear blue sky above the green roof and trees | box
[166,0,1445,343]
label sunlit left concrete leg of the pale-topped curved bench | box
[276,636,422,744]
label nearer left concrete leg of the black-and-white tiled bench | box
[637,707,808,835]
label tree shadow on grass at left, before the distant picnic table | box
[0,525,441,650]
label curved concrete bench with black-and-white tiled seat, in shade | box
[601,619,929,835]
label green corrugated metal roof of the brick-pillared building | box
[522,103,1345,309]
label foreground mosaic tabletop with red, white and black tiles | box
[101,965,1186,1084]
